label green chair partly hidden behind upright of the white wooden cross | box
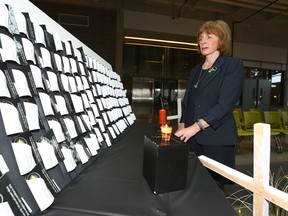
[243,111,283,154]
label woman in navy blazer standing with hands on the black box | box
[175,20,244,188]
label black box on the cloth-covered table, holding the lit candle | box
[143,135,189,194]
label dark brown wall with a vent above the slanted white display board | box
[34,1,117,70]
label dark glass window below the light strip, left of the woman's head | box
[123,44,199,79]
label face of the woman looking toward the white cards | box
[198,32,219,56]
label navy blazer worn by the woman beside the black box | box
[180,54,244,146]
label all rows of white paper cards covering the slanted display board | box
[0,3,136,216]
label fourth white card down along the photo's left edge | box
[0,102,23,135]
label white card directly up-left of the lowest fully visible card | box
[11,140,36,175]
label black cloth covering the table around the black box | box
[40,124,236,216]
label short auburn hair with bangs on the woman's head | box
[197,20,231,55]
